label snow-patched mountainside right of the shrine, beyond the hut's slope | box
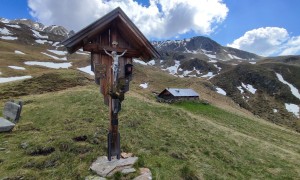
[152,36,300,131]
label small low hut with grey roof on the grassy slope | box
[157,88,199,100]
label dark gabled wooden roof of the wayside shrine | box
[62,7,160,60]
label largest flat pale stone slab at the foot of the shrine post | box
[90,156,138,177]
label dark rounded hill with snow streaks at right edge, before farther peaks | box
[212,64,300,131]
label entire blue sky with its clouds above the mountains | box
[0,0,300,56]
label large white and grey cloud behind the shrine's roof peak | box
[28,0,228,38]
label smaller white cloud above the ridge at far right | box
[227,27,300,56]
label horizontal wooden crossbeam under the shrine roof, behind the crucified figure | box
[83,43,142,58]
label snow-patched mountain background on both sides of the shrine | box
[0,19,300,131]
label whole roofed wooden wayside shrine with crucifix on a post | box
[62,8,160,160]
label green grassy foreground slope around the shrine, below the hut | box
[0,86,300,179]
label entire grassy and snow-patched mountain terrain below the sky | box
[0,16,300,179]
